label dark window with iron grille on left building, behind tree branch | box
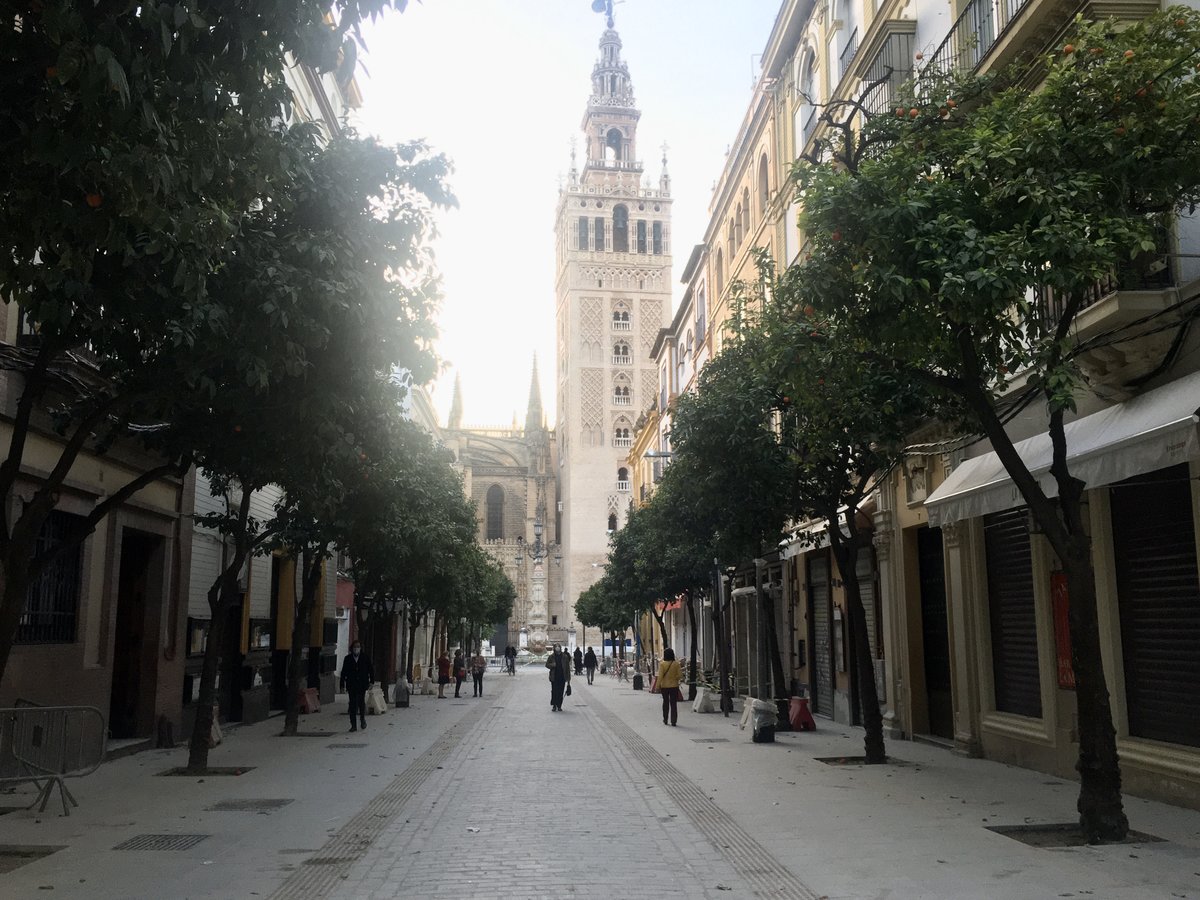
[17,510,83,643]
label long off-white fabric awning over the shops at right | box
[925,372,1200,526]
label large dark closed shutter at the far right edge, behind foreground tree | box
[1110,464,1200,746]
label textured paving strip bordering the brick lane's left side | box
[269,707,499,900]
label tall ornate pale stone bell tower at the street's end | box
[554,18,671,646]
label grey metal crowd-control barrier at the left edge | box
[0,706,107,816]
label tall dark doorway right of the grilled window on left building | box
[108,529,162,740]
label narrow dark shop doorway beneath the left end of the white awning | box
[917,528,954,738]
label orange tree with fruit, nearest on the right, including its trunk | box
[776,7,1200,841]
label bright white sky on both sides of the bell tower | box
[358,0,779,426]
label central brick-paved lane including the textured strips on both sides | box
[295,672,816,900]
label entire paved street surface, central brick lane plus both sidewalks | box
[0,668,1200,900]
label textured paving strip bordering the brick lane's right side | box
[588,703,821,900]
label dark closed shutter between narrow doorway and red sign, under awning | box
[983,506,1042,719]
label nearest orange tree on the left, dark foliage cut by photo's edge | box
[0,0,417,677]
